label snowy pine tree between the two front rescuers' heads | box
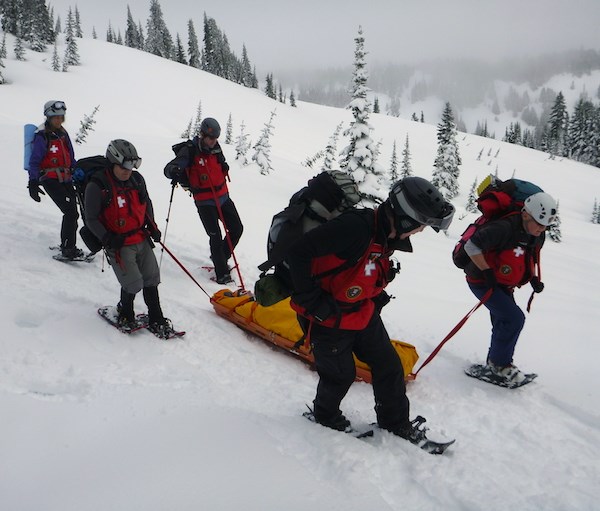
[431,103,462,200]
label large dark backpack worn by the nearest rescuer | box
[254,170,361,307]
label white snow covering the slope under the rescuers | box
[0,37,600,511]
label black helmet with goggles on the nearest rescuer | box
[389,177,454,233]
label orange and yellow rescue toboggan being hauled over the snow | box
[210,289,419,383]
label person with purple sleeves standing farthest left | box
[27,100,83,259]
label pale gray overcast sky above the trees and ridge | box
[49,0,600,74]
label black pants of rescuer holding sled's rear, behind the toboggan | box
[196,199,244,278]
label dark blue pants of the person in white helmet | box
[469,284,525,366]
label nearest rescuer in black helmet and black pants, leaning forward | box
[286,177,454,444]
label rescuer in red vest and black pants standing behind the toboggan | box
[164,117,244,284]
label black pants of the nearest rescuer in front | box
[298,314,409,430]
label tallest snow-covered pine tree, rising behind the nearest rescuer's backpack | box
[341,27,383,201]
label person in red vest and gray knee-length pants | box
[85,139,173,338]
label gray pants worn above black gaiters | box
[106,239,160,295]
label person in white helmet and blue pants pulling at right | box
[464,192,557,387]
